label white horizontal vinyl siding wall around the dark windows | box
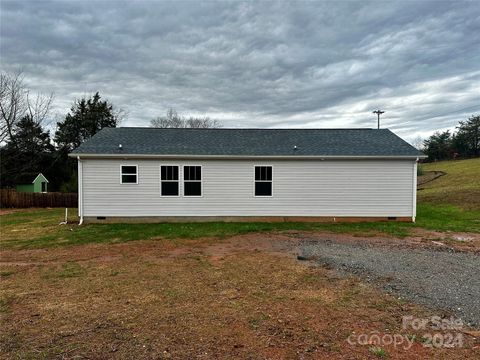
[82,159,415,217]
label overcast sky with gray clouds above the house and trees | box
[0,0,480,141]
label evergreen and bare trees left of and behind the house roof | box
[0,72,221,192]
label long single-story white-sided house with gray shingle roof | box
[69,127,425,222]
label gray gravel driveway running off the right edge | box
[299,239,480,326]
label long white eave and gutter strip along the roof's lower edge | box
[68,153,427,160]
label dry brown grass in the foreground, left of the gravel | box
[0,234,480,359]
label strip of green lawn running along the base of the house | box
[0,203,480,249]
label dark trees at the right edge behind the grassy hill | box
[420,115,480,161]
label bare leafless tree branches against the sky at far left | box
[0,71,53,143]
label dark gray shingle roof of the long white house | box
[71,127,423,157]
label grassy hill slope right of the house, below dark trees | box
[418,158,480,210]
